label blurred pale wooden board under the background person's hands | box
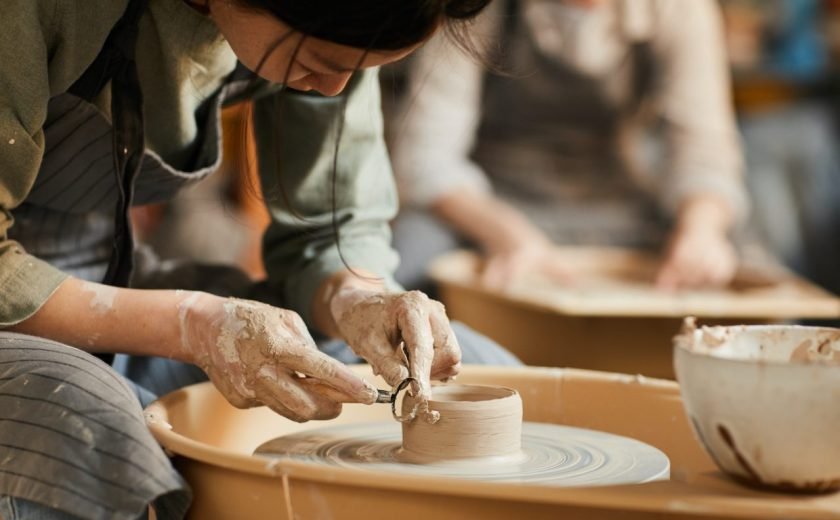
[430,248,840,320]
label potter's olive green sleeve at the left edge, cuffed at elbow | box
[0,0,125,328]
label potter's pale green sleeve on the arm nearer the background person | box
[254,70,397,330]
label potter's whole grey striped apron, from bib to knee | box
[0,0,242,520]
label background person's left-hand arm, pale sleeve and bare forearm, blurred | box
[393,7,564,287]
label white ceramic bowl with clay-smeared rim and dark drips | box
[674,319,840,492]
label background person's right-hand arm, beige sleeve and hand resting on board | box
[653,0,748,289]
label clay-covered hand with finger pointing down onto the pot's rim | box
[330,287,461,400]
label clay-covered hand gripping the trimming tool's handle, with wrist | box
[178,292,376,422]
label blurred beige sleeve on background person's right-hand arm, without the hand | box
[654,0,749,221]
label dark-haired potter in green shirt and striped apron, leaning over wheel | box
[0,0,506,519]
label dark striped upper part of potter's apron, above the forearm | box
[9,88,228,282]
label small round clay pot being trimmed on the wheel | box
[401,385,522,462]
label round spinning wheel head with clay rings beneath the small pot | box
[254,422,670,486]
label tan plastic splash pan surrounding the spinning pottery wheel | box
[147,367,840,520]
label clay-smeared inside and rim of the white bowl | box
[674,318,840,366]
